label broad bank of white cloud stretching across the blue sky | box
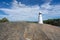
[0,0,60,21]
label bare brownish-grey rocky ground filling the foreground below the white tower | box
[0,22,60,40]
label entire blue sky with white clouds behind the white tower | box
[0,0,60,21]
